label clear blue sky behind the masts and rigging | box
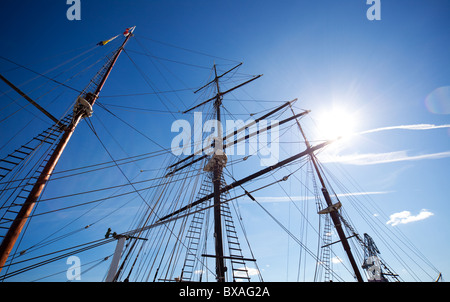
[0,0,450,281]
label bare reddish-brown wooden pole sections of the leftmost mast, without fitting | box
[0,29,132,271]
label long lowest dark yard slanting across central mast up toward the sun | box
[158,141,333,221]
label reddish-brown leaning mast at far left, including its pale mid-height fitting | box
[0,27,135,271]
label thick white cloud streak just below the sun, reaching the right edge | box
[321,151,450,165]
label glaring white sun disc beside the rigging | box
[317,108,356,140]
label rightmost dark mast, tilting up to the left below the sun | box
[291,107,363,282]
